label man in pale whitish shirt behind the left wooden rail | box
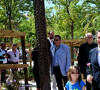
[7,44,19,73]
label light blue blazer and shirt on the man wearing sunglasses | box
[50,43,71,76]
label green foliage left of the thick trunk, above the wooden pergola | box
[0,0,36,44]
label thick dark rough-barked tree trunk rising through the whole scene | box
[33,0,51,90]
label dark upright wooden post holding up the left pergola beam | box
[21,36,29,90]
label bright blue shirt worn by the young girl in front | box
[65,80,85,90]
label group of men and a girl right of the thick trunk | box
[33,30,100,90]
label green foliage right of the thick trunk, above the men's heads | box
[47,0,100,39]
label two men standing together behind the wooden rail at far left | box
[0,42,19,83]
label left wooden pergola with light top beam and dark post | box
[0,30,29,90]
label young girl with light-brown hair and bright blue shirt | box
[65,66,85,90]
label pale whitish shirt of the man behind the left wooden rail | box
[7,49,19,63]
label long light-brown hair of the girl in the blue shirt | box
[68,66,82,82]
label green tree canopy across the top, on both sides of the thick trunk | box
[0,0,100,44]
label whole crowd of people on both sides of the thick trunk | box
[0,30,100,90]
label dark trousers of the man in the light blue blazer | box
[53,66,68,90]
